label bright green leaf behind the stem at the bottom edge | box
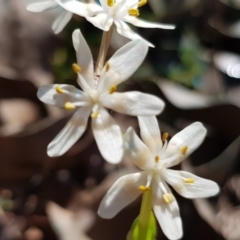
[127,211,157,240]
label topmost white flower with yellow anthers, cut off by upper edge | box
[56,0,175,47]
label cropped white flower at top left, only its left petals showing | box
[26,0,99,34]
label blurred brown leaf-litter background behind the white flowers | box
[0,0,240,240]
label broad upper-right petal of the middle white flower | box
[99,39,148,91]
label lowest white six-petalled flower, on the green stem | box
[98,116,219,240]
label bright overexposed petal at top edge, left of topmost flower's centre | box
[55,0,101,17]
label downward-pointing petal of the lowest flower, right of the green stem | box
[152,180,183,240]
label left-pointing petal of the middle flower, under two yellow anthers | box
[37,84,88,107]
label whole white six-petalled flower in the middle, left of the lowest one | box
[38,30,164,163]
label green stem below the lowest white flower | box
[137,188,152,240]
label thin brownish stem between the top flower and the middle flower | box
[94,25,113,76]
